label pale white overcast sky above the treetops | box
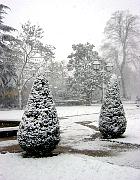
[0,0,140,60]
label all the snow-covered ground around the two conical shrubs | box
[0,104,140,180]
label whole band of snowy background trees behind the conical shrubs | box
[0,4,140,109]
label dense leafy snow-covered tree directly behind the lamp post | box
[67,43,107,104]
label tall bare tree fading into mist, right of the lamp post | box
[102,11,140,99]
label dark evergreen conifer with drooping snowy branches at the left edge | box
[0,4,16,93]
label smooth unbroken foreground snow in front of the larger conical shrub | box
[0,154,140,180]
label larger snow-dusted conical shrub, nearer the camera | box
[17,74,60,155]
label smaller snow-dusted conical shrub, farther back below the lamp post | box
[99,76,127,138]
